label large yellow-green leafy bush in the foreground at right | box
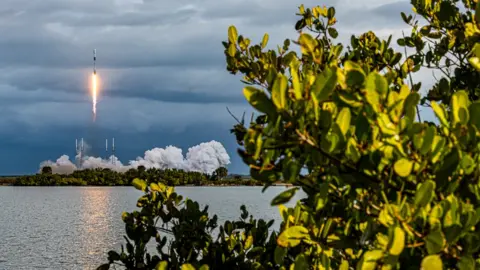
[102,0,480,269]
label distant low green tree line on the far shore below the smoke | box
[11,166,260,186]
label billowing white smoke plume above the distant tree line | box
[40,141,230,174]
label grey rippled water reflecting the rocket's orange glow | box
[0,187,300,269]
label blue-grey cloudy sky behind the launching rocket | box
[0,0,438,174]
